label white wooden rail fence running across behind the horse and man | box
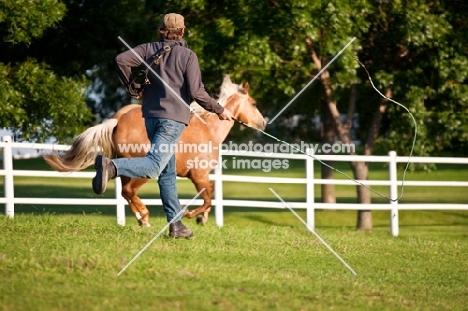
[0,136,468,236]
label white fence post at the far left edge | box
[2,135,15,218]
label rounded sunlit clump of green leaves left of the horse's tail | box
[0,59,91,141]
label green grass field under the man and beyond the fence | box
[0,159,468,310]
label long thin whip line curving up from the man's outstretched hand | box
[232,58,418,202]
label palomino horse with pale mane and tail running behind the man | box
[44,76,266,226]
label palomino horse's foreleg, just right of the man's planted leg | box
[184,170,213,224]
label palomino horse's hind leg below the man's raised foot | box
[120,176,150,227]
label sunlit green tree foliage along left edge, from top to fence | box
[0,0,91,141]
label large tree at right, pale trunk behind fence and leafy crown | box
[302,1,468,229]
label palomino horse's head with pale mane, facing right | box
[220,75,266,130]
